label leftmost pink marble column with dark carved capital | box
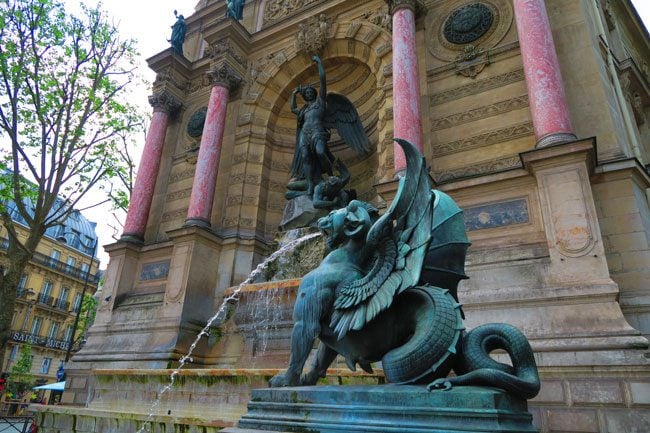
[121,91,180,242]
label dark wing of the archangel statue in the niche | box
[324,92,370,153]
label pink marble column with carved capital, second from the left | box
[185,64,240,227]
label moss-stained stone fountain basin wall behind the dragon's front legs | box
[32,368,383,433]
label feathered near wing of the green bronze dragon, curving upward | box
[330,139,433,339]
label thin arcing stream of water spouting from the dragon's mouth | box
[137,232,321,433]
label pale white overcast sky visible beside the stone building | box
[78,0,650,268]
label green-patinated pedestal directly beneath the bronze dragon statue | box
[230,385,537,433]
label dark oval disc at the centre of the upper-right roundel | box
[443,3,494,44]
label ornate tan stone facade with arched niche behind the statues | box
[49,0,650,432]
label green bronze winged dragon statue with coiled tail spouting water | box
[269,139,540,399]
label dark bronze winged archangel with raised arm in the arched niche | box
[287,55,370,198]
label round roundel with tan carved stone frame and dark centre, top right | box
[426,0,514,62]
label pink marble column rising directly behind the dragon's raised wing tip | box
[388,0,424,175]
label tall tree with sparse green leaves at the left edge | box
[0,0,142,365]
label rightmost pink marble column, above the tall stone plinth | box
[513,0,576,147]
